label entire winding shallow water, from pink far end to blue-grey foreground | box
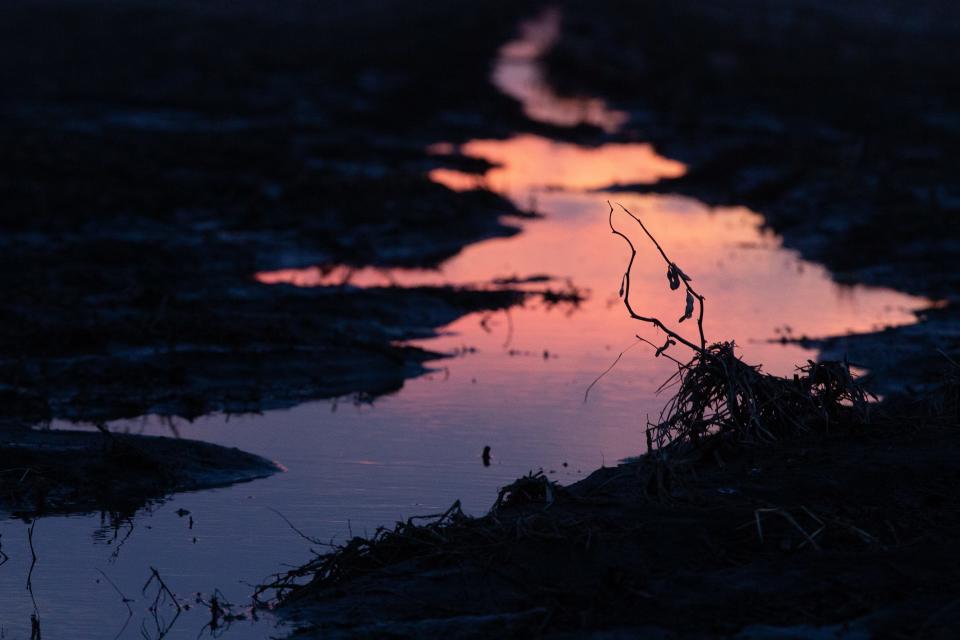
[0,6,926,638]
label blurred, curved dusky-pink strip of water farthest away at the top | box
[492,9,628,133]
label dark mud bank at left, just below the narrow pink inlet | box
[0,283,524,423]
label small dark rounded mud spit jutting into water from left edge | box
[0,426,281,517]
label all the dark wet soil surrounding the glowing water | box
[0,0,960,637]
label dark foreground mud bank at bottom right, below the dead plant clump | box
[268,408,960,638]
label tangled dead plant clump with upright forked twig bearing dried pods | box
[609,205,871,458]
